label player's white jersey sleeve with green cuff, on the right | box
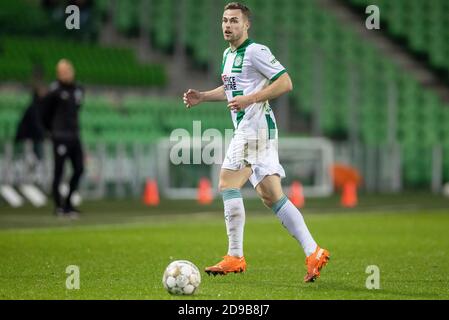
[251,46,287,81]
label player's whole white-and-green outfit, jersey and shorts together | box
[222,39,286,187]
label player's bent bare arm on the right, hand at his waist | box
[228,72,293,111]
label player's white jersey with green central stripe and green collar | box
[221,39,286,131]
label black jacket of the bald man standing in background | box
[42,81,84,140]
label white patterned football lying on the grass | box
[162,260,201,295]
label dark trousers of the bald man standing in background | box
[53,139,84,208]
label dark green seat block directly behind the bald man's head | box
[0,37,166,86]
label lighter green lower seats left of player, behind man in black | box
[0,94,232,143]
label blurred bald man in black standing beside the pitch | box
[42,59,84,218]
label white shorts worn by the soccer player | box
[221,115,285,188]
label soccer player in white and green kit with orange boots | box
[183,2,330,282]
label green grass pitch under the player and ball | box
[0,196,449,300]
